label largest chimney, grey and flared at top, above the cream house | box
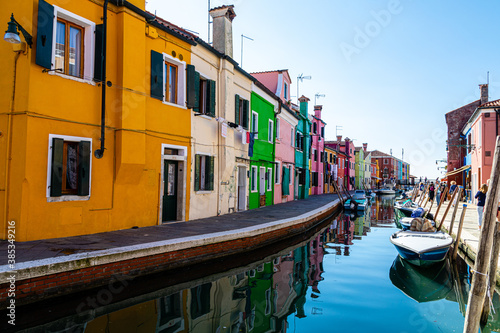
[209,5,236,58]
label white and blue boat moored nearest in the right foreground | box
[390,230,453,266]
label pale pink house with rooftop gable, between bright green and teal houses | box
[252,69,299,204]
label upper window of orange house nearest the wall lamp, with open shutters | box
[35,0,96,81]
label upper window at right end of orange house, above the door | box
[151,50,186,106]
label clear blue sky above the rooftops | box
[146,0,500,178]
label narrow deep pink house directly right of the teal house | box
[311,105,326,195]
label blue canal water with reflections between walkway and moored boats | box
[8,197,500,333]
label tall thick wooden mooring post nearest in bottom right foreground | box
[464,136,500,333]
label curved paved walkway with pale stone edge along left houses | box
[0,194,344,271]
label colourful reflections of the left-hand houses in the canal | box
[79,237,328,333]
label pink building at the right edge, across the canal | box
[462,100,500,191]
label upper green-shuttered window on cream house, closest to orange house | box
[186,65,215,117]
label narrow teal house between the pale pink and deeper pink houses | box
[295,96,311,199]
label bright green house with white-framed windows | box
[248,87,278,209]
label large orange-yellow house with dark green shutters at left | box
[0,0,196,241]
